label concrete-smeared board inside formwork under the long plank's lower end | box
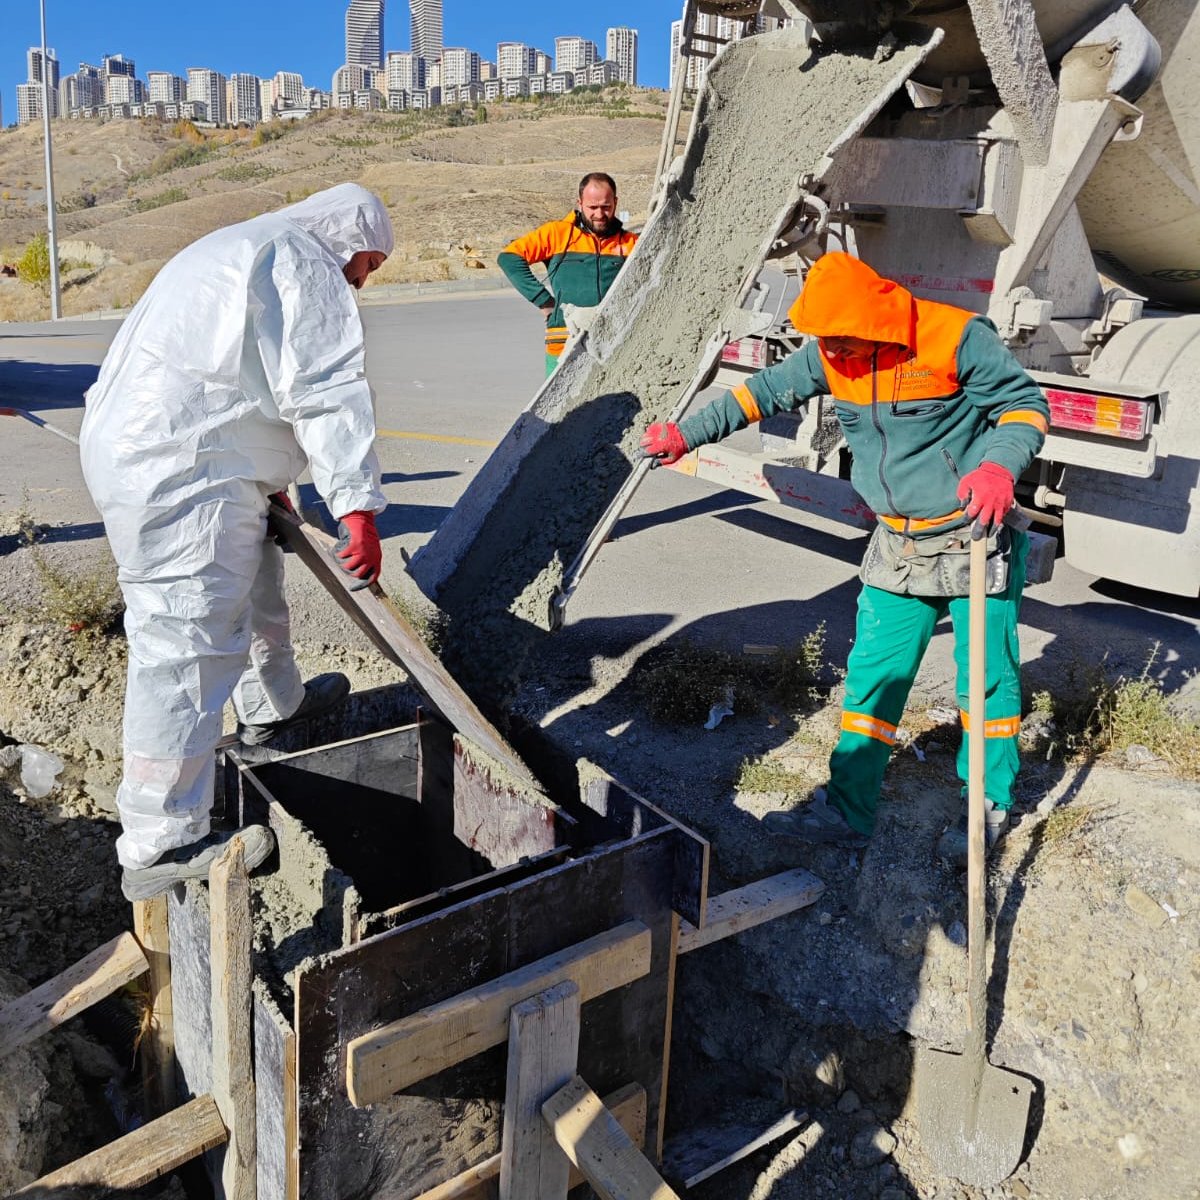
[454,736,558,868]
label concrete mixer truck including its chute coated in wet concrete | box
[409,0,1200,662]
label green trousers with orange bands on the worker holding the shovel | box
[828,530,1028,834]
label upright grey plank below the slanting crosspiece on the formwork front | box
[500,983,580,1200]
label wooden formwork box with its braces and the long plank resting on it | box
[0,512,822,1200]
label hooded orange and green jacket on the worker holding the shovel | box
[679,252,1050,538]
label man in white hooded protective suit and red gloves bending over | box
[80,184,392,900]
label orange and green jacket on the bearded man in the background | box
[497,211,637,358]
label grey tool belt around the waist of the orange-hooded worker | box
[858,524,1013,596]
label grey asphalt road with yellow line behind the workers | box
[0,295,1200,701]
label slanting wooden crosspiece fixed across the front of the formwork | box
[346,920,650,1108]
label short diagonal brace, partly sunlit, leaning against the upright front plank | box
[541,1075,679,1200]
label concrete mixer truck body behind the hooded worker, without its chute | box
[681,0,1200,596]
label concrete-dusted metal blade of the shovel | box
[917,1048,1033,1188]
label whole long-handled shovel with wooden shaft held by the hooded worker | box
[917,538,1033,1188]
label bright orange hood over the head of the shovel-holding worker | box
[787,250,916,347]
